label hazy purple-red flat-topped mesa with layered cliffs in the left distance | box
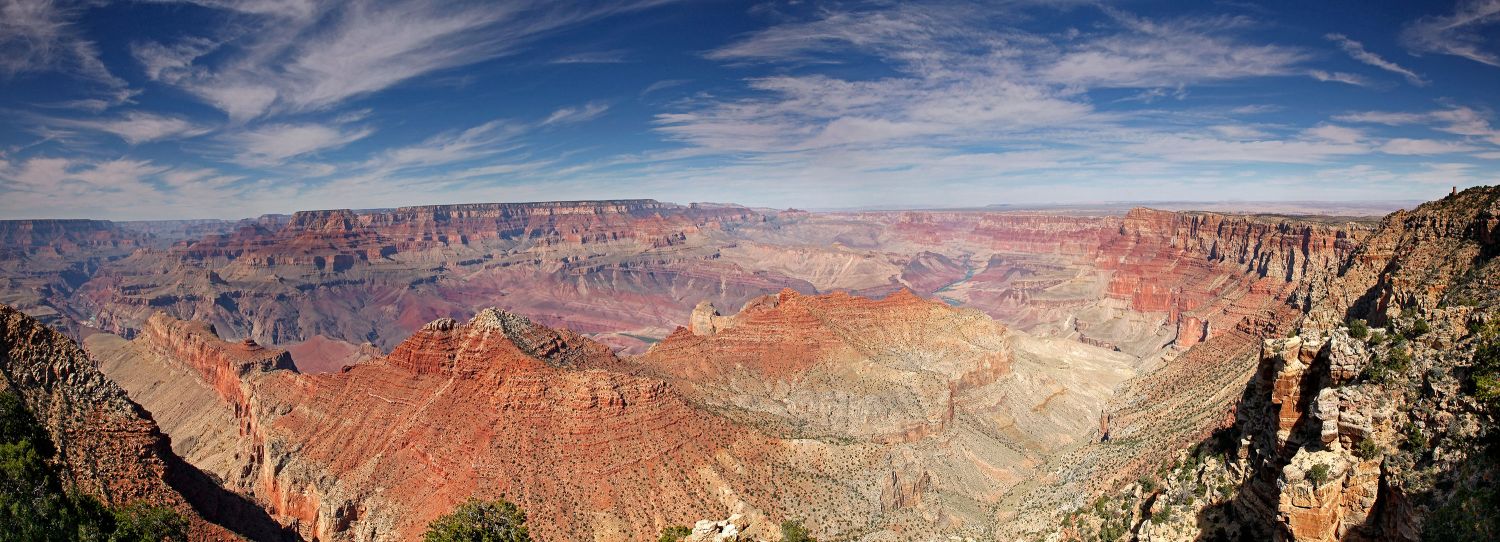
[74,200,768,350]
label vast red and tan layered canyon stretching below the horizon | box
[0,189,1497,540]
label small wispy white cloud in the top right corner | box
[1401,0,1500,68]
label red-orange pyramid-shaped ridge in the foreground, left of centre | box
[102,303,878,540]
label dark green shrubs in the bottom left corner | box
[0,393,188,542]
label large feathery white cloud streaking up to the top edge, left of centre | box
[135,0,678,120]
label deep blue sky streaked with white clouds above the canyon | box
[0,0,1500,219]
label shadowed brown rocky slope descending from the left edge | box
[0,301,284,540]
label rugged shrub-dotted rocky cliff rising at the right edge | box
[1065,188,1500,540]
